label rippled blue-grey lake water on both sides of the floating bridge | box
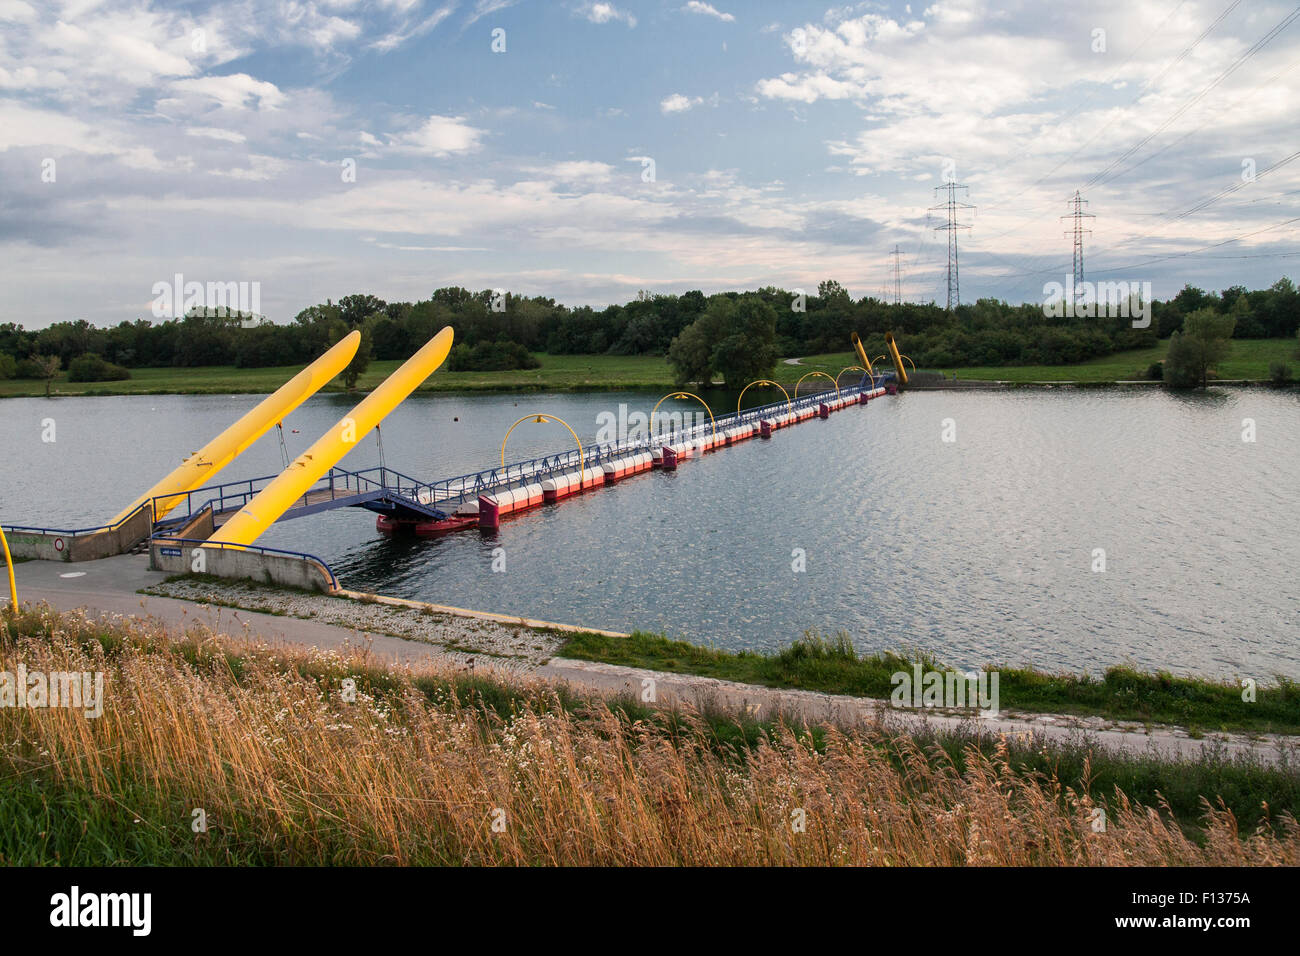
[0,389,1300,679]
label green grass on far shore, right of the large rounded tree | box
[777,338,1300,384]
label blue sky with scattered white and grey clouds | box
[0,0,1300,328]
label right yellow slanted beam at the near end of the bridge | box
[208,325,452,545]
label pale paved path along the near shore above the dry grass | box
[16,555,1300,766]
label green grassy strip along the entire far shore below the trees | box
[0,338,1300,398]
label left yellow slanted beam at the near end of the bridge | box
[109,330,361,524]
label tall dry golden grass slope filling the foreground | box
[0,609,1300,865]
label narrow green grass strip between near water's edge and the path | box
[560,633,1300,734]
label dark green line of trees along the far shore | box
[0,278,1300,381]
